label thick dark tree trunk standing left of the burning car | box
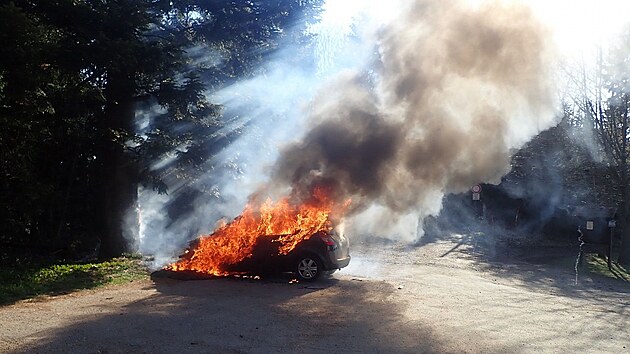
[97,75,138,258]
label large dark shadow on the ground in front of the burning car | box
[11,277,464,353]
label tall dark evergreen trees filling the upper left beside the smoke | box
[0,0,321,262]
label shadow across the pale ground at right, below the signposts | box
[417,228,630,301]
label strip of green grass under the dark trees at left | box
[0,256,149,305]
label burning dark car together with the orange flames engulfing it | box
[165,190,350,281]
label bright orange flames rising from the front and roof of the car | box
[165,188,350,276]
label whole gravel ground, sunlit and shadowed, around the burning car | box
[0,235,630,353]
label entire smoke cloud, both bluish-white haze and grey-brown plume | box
[139,0,630,263]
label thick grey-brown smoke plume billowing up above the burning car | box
[271,0,555,237]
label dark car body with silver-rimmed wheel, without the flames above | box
[230,230,350,281]
